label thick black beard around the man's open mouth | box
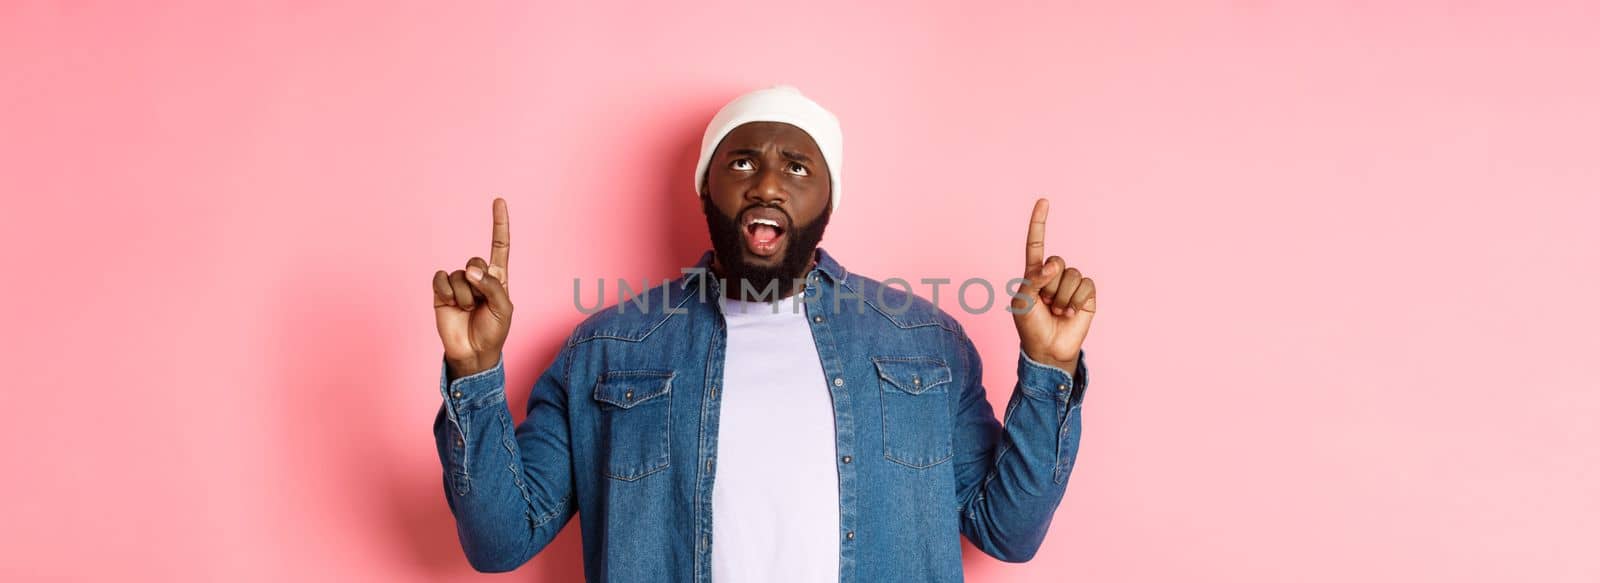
[701,197,834,300]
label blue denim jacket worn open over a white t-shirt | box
[434,250,1088,581]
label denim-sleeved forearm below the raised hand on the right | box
[962,354,1088,562]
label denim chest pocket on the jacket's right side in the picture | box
[872,357,952,468]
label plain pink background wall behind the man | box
[0,2,1600,581]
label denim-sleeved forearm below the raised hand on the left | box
[434,355,573,572]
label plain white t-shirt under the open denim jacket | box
[710,293,838,583]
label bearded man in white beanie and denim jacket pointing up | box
[434,86,1094,583]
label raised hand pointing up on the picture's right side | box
[1011,199,1094,373]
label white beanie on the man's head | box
[694,85,845,210]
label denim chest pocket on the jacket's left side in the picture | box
[594,370,674,480]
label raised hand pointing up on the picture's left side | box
[434,199,512,380]
